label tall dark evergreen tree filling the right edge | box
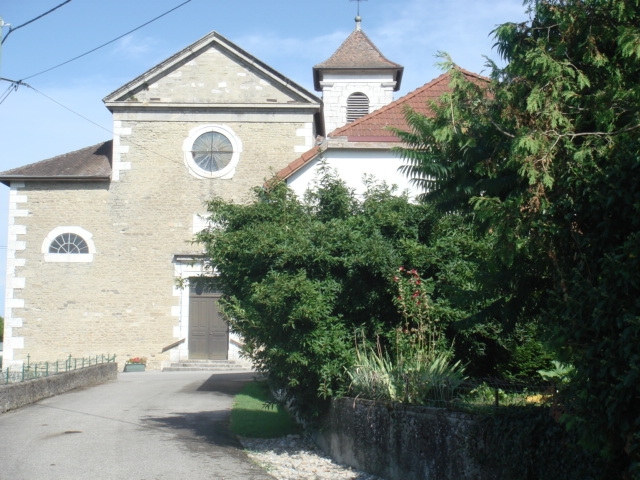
[392,0,640,475]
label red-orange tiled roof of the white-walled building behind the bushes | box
[276,67,489,180]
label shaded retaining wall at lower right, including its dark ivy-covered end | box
[314,398,604,480]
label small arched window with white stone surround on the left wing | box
[42,227,96,263]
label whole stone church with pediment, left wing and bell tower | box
[0,17,410,369]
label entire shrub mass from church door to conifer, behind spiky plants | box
[197,171,548,417]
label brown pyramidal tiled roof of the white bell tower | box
[313,28,404,91]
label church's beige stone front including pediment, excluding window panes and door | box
[4,31,319,368]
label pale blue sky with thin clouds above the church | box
[0,0,527,312]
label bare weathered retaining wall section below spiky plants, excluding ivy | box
[314,398,493,480]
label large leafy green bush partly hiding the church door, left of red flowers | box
[198,173,426,418]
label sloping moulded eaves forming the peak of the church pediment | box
[107,31,321,109]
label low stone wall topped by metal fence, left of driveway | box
[0,362,118,413]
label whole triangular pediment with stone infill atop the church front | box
[103,32,320,108]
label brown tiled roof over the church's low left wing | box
[0,140,113,185]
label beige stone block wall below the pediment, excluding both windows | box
[4,113,311,369]
